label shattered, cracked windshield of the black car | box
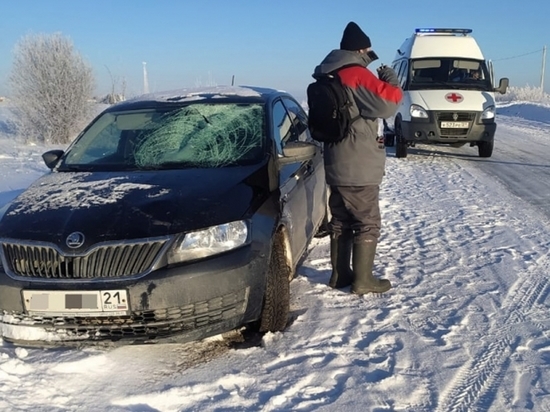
[58,103,265,171]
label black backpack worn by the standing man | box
[307,72,360,143]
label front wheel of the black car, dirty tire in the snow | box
[258,232,292,332]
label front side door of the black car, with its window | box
[272,99,325,265]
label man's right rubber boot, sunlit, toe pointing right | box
[351,241,391,295]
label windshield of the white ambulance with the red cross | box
[409,58,492,91]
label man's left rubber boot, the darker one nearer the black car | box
[328,232,353,289]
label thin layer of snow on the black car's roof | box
[127,86,282,102]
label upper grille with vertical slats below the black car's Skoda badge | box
[2,238,168,279]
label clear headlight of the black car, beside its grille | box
[167,220,249,263]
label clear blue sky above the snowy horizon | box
[0,0,550,99]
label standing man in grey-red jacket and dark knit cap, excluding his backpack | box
[314,22,402,295]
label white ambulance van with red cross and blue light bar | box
[386,28,508,158]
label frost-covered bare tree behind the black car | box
[9,33,94,144]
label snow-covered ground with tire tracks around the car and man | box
[0,102,550,412]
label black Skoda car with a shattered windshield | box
[0,87,327,343]
